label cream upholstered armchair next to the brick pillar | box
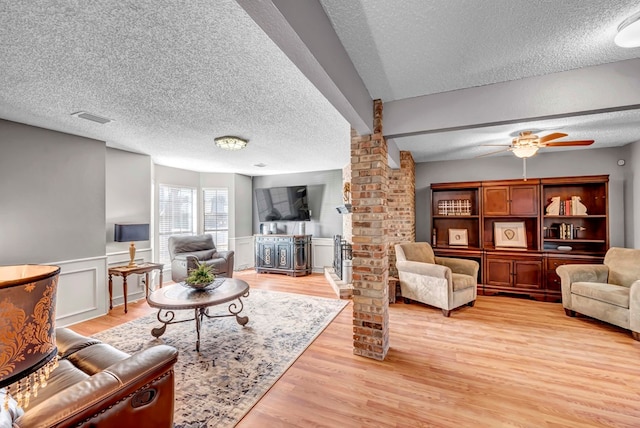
[395,242,480,317]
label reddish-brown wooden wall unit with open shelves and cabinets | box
[431,175,609,301]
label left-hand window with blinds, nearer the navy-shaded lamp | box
[158,184,197,264]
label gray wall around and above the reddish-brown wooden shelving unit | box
[416,147,638,246]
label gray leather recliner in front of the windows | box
[168,234,234,282]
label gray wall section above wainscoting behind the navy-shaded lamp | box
[105,148,152,253]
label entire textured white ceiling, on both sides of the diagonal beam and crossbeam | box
[0,0,640,175]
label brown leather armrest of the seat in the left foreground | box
[13,345,178,427]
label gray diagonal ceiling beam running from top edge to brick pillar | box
[237,0,373,135]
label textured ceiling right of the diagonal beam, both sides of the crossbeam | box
[320,0,640,162]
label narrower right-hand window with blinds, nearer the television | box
[202,189,229,251]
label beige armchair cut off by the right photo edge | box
[556,247,640,340]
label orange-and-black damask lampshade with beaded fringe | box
[0,265,60,408]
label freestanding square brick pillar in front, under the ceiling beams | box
[351,100,389,360]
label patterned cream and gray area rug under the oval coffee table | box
[94,289,348,428]
